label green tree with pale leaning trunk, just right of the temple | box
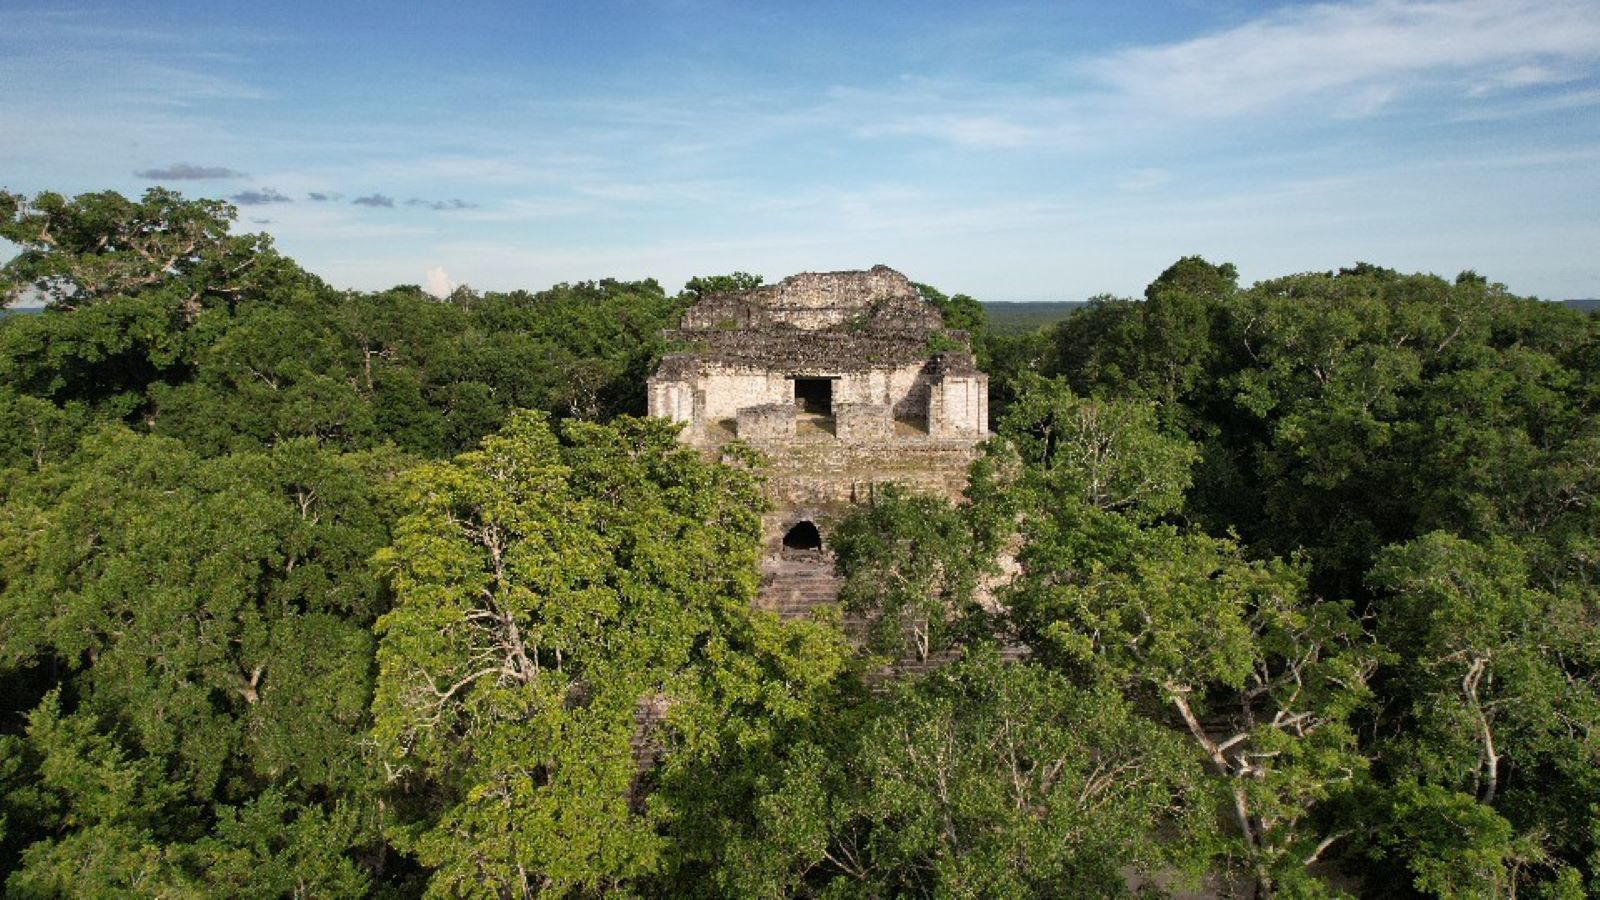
[986,374,1376,892]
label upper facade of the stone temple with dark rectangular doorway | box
[648,266,989,448]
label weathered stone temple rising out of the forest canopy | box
[648,266,989,615]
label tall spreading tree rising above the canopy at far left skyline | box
[0,189,326,438]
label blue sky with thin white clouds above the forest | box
[0,0,1600,299]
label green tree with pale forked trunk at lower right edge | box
[1371,532,1600,884]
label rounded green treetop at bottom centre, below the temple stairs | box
[700,655,1208,897]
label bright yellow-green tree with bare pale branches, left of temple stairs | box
[374,413,838,895]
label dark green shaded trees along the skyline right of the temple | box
[1050,259,1597,594]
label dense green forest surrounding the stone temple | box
[0,189,1600,898]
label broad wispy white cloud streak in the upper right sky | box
[825,0,1600,152]
